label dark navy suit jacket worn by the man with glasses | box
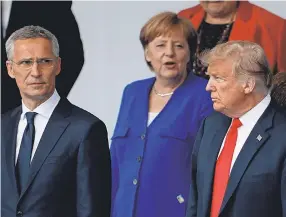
[1,99,111,217]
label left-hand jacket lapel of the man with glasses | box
[2,106,22,195]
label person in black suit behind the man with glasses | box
[1,1,84,113]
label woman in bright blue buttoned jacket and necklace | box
[111,12,213,217]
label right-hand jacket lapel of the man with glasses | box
[20,99,71,199]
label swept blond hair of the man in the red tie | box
[200,41,273,89]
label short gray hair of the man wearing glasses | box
[5,25,60,60]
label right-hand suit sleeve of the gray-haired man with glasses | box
[77,121,111,217]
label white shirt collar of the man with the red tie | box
[239,94,271,127]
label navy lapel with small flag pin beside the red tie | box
[220,104,275,212]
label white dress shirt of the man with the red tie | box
[219,94,271,172]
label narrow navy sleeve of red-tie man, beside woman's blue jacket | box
[186,120,205,217]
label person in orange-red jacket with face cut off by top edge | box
[179,1,286,78]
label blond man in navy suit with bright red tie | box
[186,41,286,217]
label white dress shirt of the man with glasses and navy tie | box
[15,90,60,165]
